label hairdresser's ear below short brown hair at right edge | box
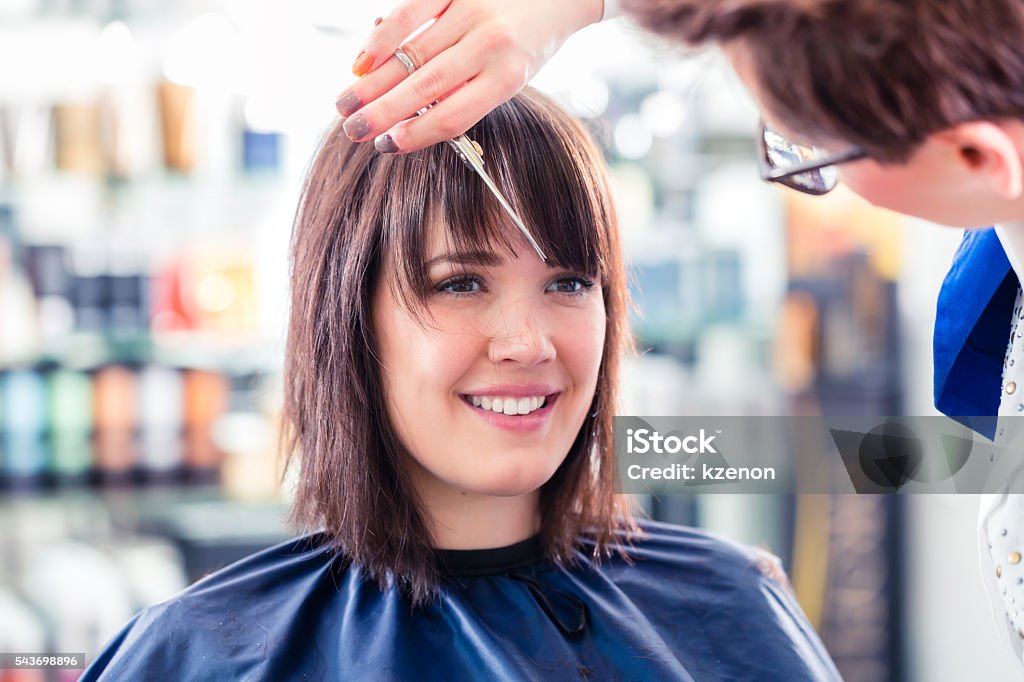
[933,121,1024,199]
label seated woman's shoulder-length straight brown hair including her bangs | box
[285,91,635,603]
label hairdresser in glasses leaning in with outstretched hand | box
[337,0,1024,660]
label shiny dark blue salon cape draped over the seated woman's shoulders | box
[81,522,841,682]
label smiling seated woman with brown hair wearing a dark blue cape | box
[75,87,839,681]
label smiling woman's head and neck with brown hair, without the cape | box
[286,86,630,600]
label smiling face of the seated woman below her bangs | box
[373,224,605,508]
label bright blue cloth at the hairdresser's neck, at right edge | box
[933,227,1018,438]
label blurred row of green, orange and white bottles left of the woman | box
[0,364,270,489]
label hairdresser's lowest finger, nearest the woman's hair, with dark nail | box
[374,75,520,154]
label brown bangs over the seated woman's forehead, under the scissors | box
[381,87,615,304]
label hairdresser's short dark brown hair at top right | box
[625,0,1024,162]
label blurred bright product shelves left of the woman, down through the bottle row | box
[0,3,296,499]
